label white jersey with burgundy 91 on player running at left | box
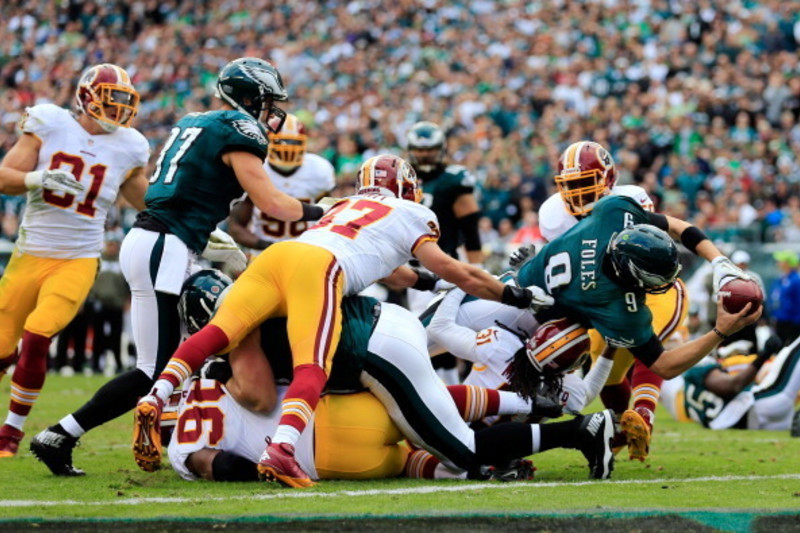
[17,104,150,259]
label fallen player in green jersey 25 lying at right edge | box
[662,336,800,431]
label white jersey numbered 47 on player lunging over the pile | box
[297,194,439,296]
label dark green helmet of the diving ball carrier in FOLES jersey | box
[608,224,681,294]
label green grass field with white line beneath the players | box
[0,376,800,531]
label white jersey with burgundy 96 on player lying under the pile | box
[167,379,317,481]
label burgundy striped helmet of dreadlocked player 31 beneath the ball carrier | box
[525,318,590,374]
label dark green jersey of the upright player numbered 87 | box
[145,110,267,253]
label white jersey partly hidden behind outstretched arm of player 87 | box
[250,153,336,242]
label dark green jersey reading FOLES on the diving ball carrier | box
[517,196,653,348]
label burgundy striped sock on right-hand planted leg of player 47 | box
[272,364,328,445]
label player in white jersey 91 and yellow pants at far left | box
[0,63,150,457]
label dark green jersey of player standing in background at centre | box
[418,165,475,257]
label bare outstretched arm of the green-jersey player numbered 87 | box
[222,152,325,222]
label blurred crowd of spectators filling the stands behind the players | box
[0,0,800,252]
